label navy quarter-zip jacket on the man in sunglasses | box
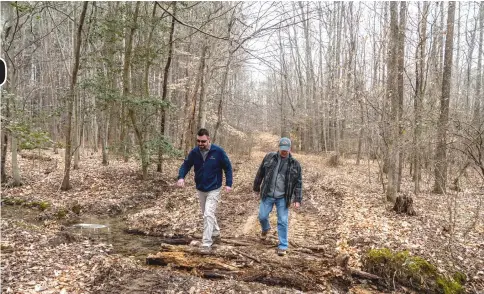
[178,144,232,192]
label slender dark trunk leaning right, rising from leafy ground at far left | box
[61,1,89,191]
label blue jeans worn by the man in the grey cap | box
[259,197,289,250]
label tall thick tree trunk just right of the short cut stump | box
[434,1,455,194]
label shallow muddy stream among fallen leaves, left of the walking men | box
[1,205,161,262]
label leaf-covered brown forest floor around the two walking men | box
[1,134,484,293]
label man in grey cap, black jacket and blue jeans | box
[253,137,302,256]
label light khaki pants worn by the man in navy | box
[197,187,222,246]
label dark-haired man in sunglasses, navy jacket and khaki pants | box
[177,129,232,253]
